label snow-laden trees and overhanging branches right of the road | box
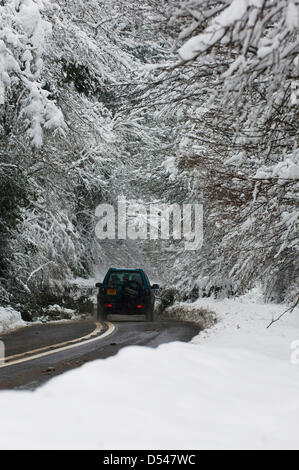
[139,0,299,300]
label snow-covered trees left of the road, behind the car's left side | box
[0,0,173,312]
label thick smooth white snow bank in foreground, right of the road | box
[0,292,299,449]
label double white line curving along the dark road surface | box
[0,321,115,369]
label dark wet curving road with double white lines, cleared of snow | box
[0,319,199,390]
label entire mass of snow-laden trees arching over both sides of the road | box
[0,0,298,316]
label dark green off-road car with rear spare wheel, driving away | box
[96,268,159,321]
